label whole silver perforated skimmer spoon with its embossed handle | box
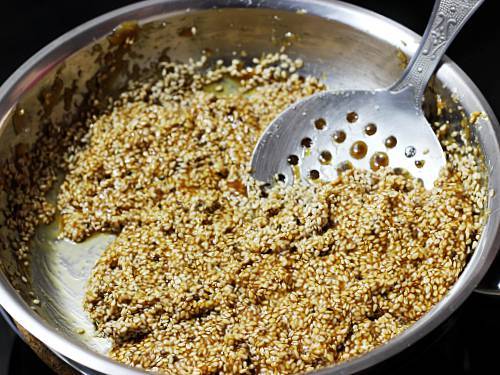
[251,0,484,189]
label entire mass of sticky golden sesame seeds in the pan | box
[3,55,487,374]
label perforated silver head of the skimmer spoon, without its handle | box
[252,89,446,187]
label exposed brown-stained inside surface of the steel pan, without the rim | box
[0,2,491,370]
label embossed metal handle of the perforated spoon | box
[390,0,484,106]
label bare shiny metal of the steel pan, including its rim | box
[0,0,500,374]
